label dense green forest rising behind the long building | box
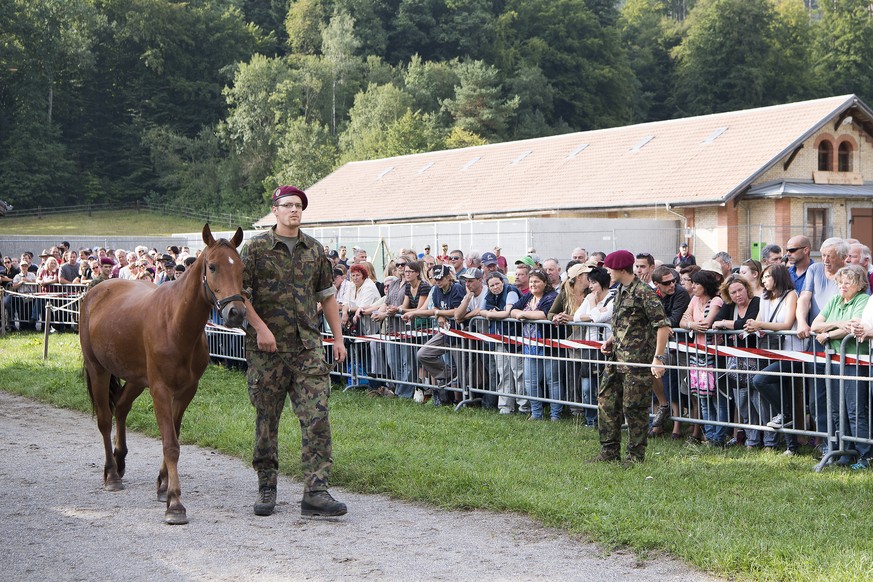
[0,0,873,214]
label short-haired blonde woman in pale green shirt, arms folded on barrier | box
[810,265,873,469]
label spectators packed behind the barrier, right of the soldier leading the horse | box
[318,236,873,467]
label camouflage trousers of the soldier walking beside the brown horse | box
[246,350,333,491]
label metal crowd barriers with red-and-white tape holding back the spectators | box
[0,296,873,471]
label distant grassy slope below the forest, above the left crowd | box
[0,209,211,237]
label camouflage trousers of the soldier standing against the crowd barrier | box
[597,364,652,460]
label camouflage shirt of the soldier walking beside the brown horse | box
[240,229,336,352]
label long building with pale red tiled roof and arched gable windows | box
[256,95,873,259]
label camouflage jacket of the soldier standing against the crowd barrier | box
[612,277,670,364]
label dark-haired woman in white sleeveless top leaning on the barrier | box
[743,263,804,455]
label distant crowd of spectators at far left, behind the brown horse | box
[0,241,200,331]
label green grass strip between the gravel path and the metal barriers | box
[0,333,873,581]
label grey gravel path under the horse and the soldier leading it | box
[0,391,714,582]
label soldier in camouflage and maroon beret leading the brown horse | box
[240,186,346,516]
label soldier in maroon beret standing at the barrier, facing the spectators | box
[592,251,670,466]
